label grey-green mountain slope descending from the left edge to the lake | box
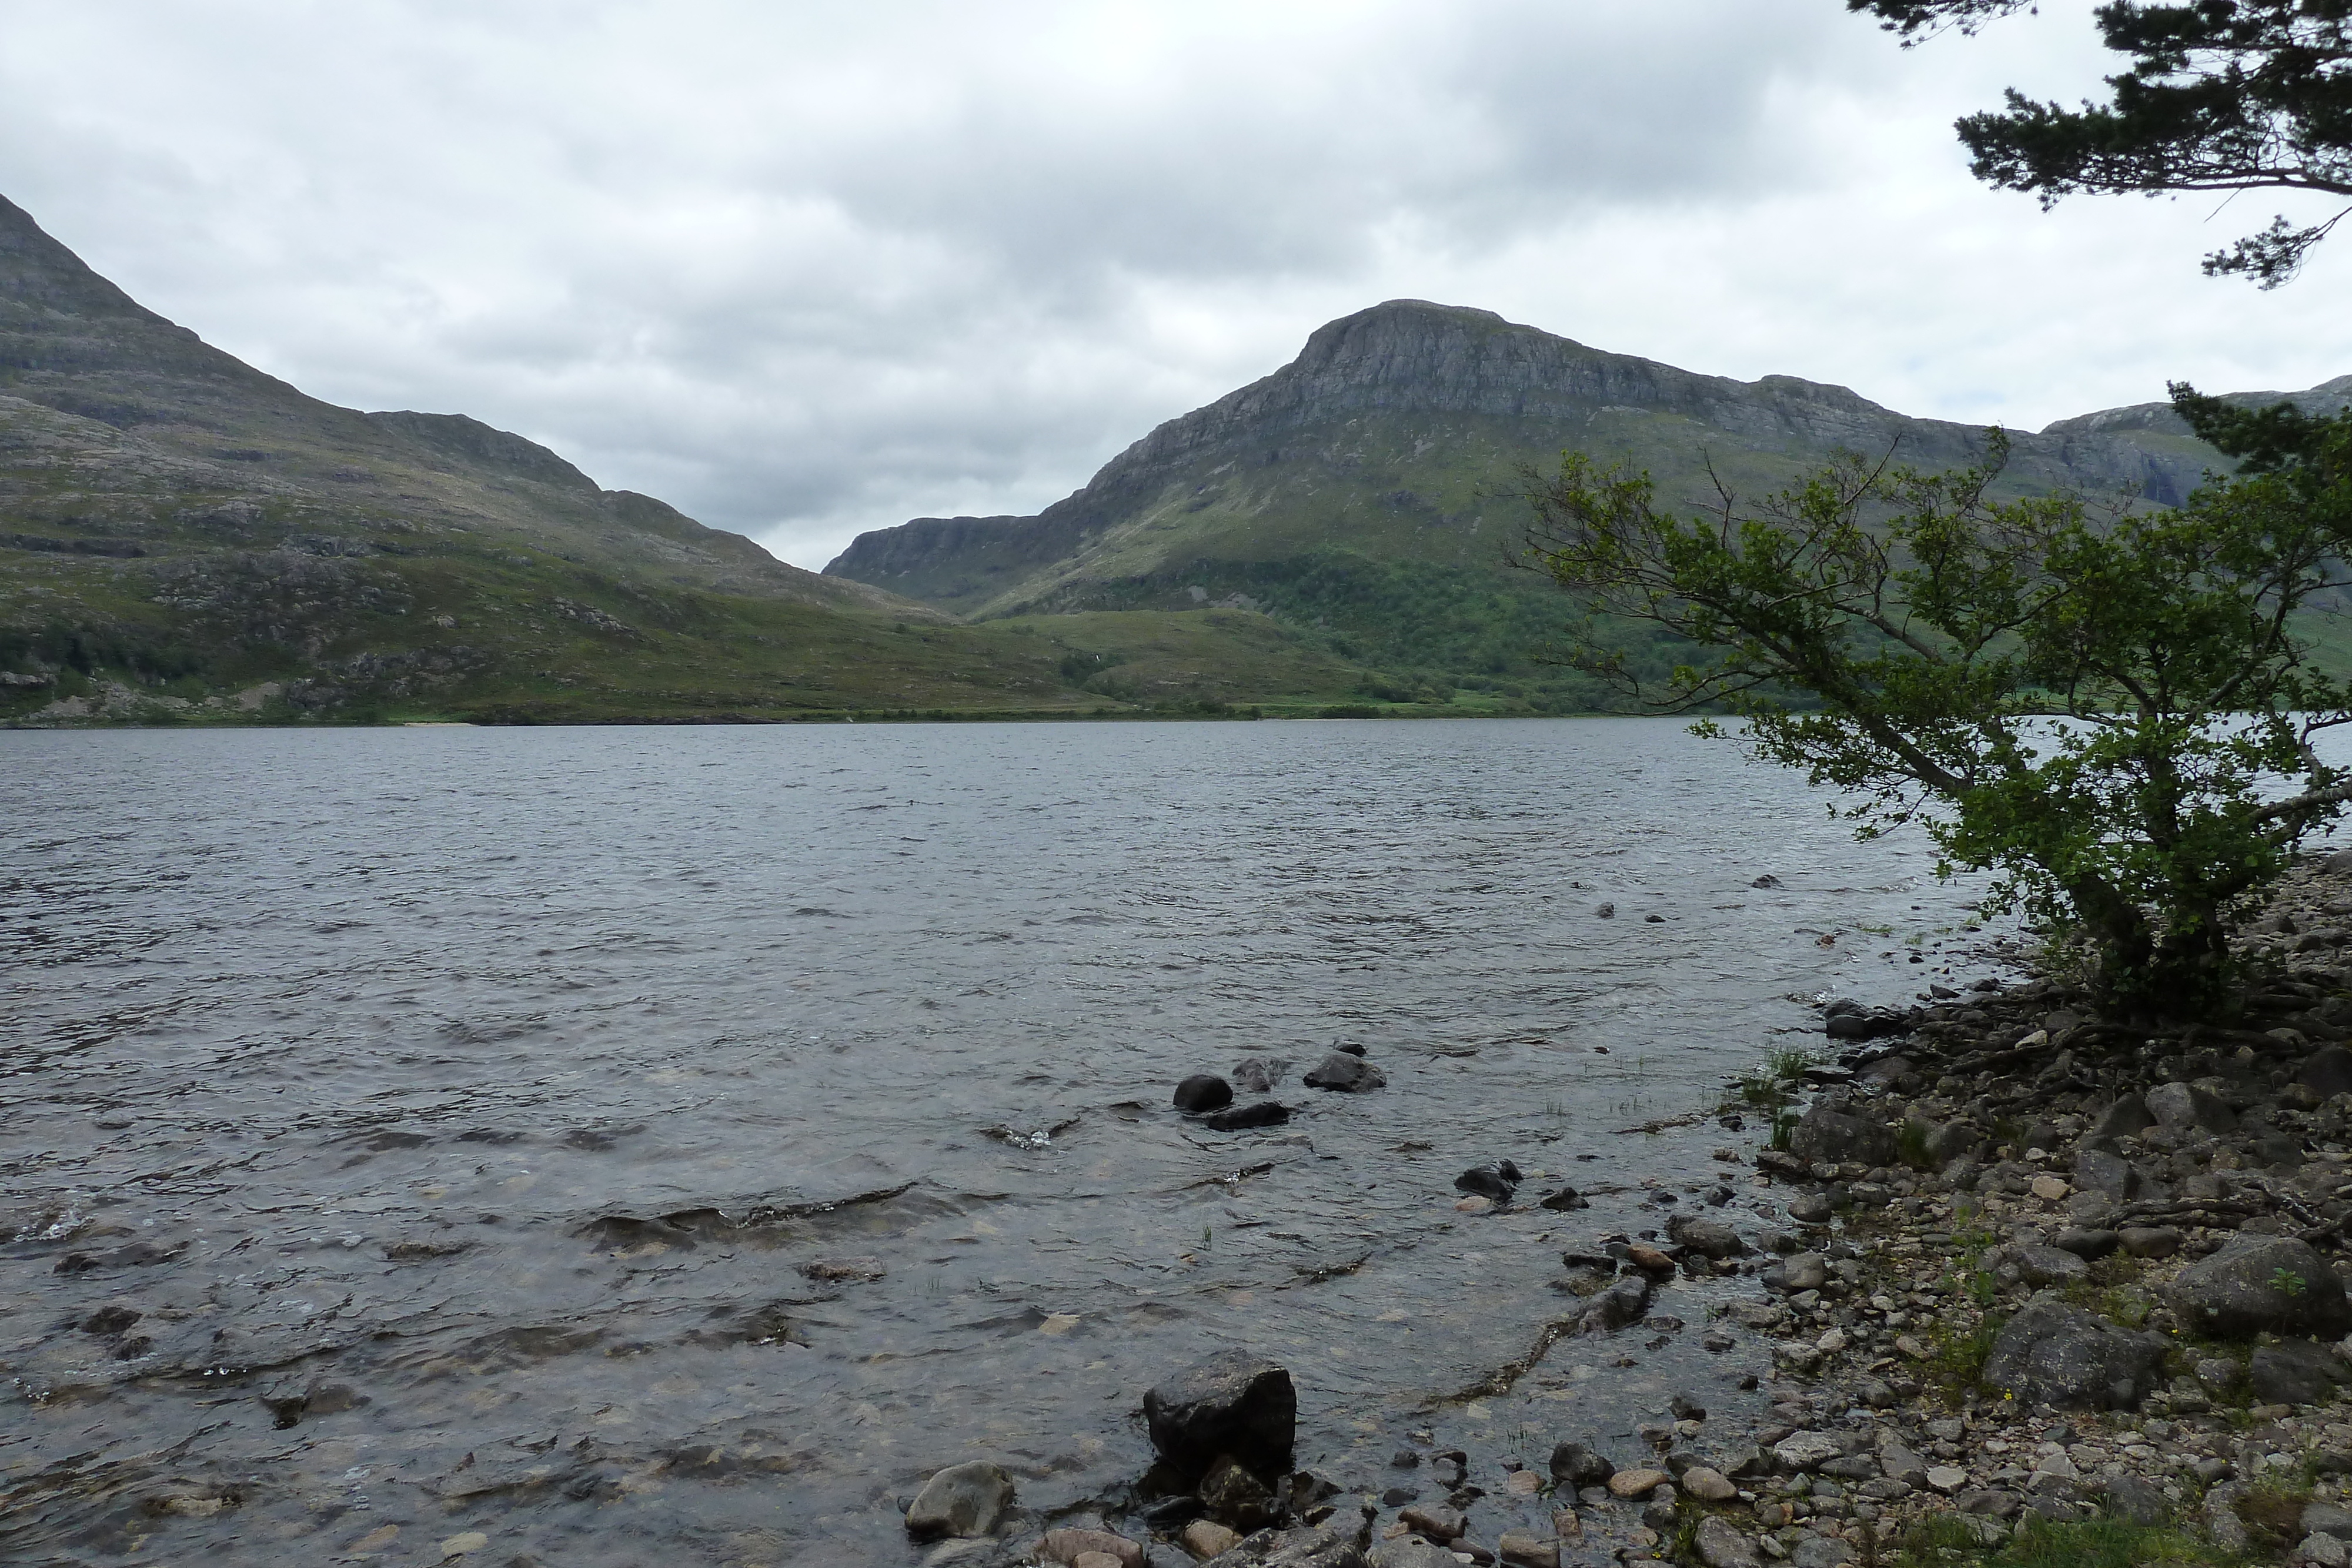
[0,200,1157,722]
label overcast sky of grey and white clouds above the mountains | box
[0,0,2352,567]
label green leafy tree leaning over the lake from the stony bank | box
[1526,386,2352,1015]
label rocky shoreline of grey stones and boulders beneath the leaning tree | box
[908,853,2352,1568]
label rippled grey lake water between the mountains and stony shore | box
[0,720,2004,1566]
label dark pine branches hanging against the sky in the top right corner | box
[1846,0,2352,289]
